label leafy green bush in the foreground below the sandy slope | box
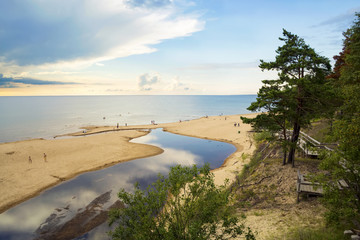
[110,165,255,240]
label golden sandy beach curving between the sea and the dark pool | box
[0,114,255,213]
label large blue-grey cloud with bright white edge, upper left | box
[0,0,204,72]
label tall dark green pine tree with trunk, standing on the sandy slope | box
[243,29,333,165]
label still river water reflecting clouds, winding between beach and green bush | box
[0,129,236,239]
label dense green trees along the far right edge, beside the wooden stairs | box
[321,14,360,227]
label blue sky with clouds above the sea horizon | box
[0,0,360,96]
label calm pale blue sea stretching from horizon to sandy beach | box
[0,95,256,142]
